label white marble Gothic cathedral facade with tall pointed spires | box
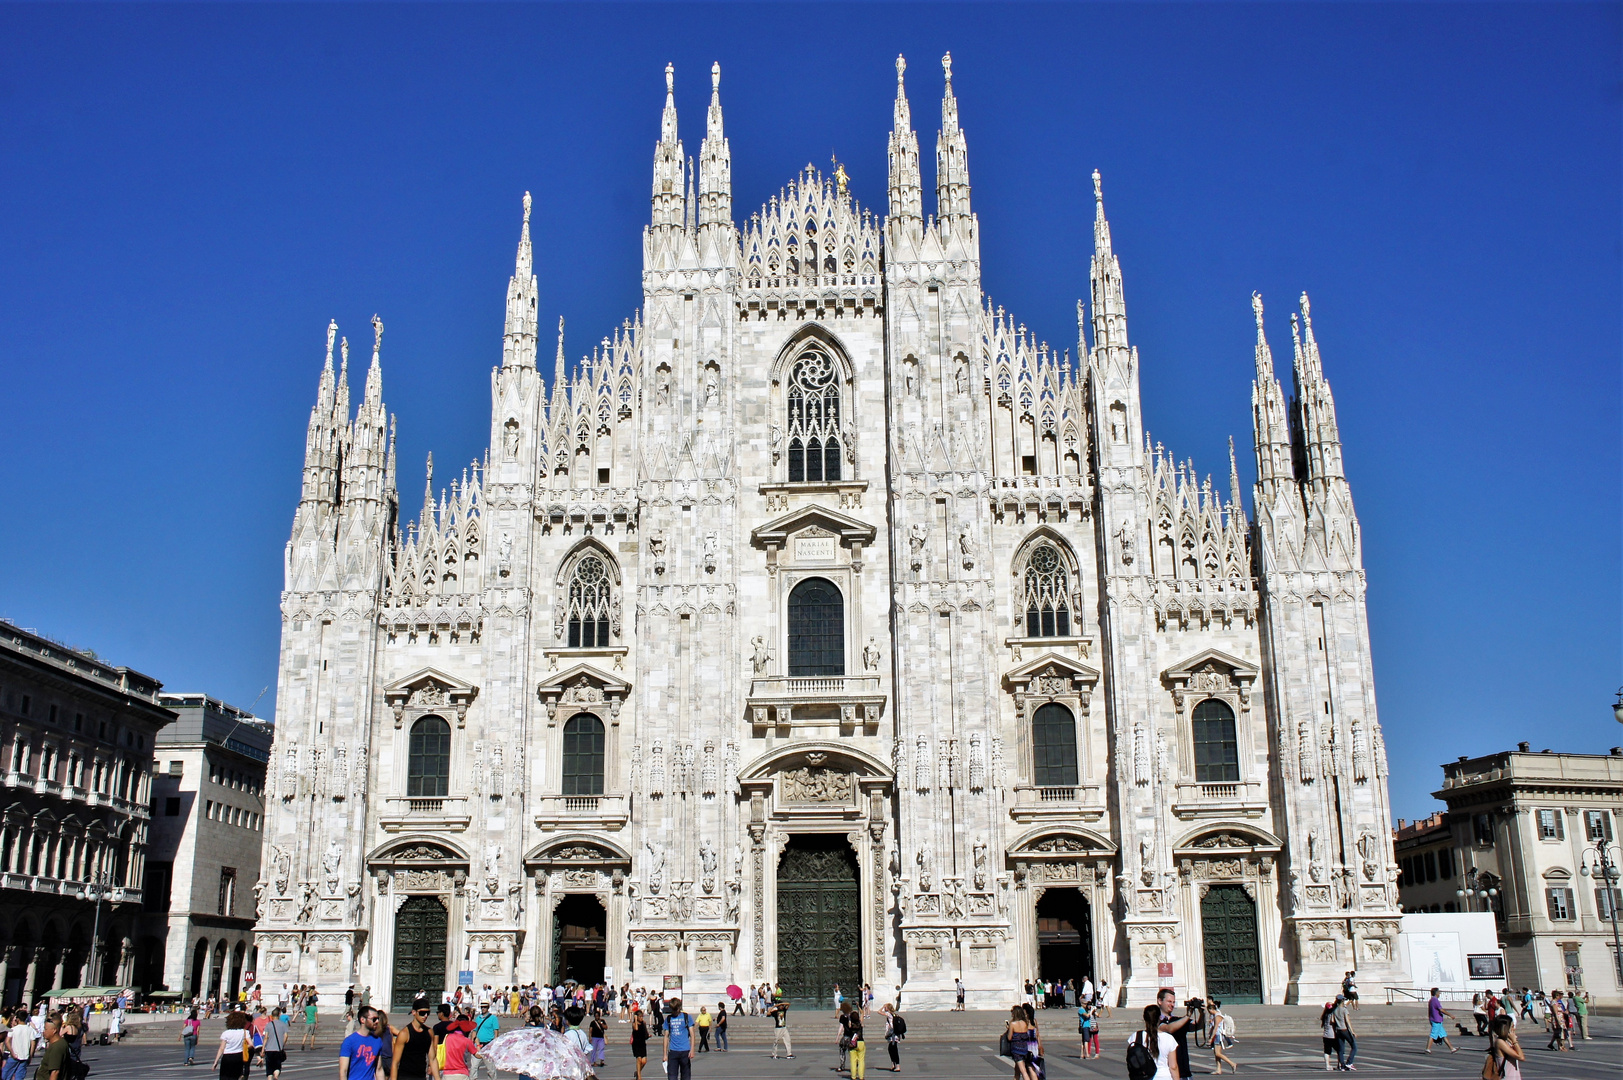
[256,58,1399,1007]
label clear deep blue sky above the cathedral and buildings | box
[0,3,1623,817]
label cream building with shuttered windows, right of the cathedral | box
[1421,742,1623,1002]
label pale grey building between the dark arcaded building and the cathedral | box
[144,693,271,1000]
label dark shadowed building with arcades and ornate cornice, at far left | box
[0,622,175,1005]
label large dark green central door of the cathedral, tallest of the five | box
[777,836,862,1009]
